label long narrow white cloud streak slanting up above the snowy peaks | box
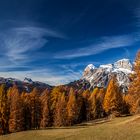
[54,35,137,59]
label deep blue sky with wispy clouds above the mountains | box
[0,0,140,85]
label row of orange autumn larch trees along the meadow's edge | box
[0,52,140,134]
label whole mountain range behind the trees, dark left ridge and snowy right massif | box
[0,59,134,92]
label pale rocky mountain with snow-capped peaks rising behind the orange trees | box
[82,59,134,91]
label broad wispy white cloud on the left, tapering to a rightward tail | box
[0,27,65,64]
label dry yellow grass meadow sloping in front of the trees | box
[0,115,140,140]
